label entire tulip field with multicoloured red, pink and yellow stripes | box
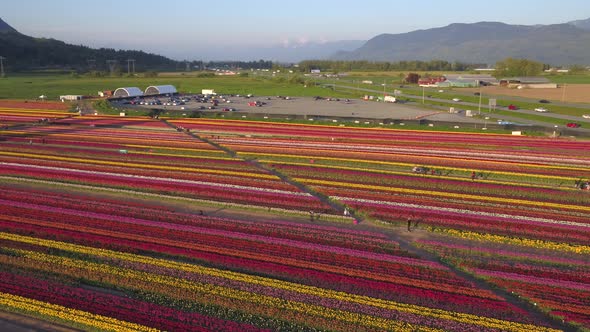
[0,107,590,331]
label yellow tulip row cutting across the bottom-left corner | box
[0,293,158,332]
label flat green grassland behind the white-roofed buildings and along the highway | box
[0,73,590,130]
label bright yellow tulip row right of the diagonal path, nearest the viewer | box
[432,228,590,255]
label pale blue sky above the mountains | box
[0,0,590,59]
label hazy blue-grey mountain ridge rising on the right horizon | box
[331,19,590,65]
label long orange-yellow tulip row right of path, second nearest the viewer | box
[295,178,590,212]
